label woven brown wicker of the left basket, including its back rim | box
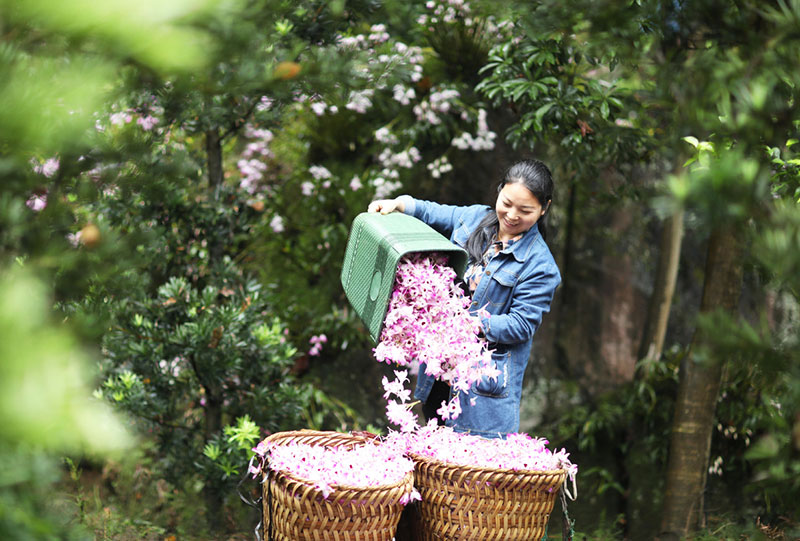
[262,430,413,541]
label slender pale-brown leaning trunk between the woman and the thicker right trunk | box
[639,210,683,360]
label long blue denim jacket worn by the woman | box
[400,195,561,438]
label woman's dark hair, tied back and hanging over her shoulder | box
[467,160,553,261]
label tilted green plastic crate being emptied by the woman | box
[342,212,467,343]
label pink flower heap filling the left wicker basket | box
[250,440,420,505]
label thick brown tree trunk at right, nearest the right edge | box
[660,228,742,541]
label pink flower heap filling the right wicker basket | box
[388,422,578,480]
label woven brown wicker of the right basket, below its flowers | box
[411,454,567,541]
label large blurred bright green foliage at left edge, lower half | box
[0,269,132,452]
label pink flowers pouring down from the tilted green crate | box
[373,253,498,431]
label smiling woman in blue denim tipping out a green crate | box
[368,160,561,438]
